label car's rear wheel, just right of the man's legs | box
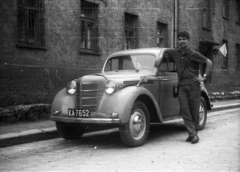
[198,97,207,130]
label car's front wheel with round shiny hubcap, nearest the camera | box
[119,101,150,147]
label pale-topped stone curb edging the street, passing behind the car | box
[0,103,240,147]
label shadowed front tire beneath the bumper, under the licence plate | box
[56,122,86,140]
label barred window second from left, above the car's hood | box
[80,0,99,53]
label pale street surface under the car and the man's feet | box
[0,108,240,172]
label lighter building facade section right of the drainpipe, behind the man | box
[178,0,240,91]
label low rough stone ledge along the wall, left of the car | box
[0,104,51,122]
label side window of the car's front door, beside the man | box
[158,57,177,75]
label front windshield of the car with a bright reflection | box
[104,54,155,72]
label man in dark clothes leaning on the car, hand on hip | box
[155,31,212,143]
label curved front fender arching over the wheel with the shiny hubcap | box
[97,86,163,123]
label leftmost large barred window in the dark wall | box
[18,0,45,47]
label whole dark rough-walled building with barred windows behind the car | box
[0,0,240,107]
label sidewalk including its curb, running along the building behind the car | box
[0,99,240,147]
